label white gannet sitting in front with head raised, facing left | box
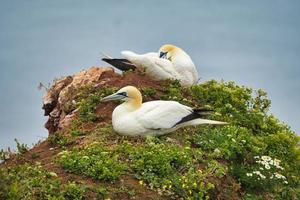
[101,86,227,136]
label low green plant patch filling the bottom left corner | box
[0,164,84,200]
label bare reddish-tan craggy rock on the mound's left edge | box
[43,67,114,134]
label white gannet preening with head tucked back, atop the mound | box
[102,44,198,86]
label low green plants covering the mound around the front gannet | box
[0,80,300,200]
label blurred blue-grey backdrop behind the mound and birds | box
[0,0,300,149]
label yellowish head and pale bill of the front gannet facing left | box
[101,86,142,108]
